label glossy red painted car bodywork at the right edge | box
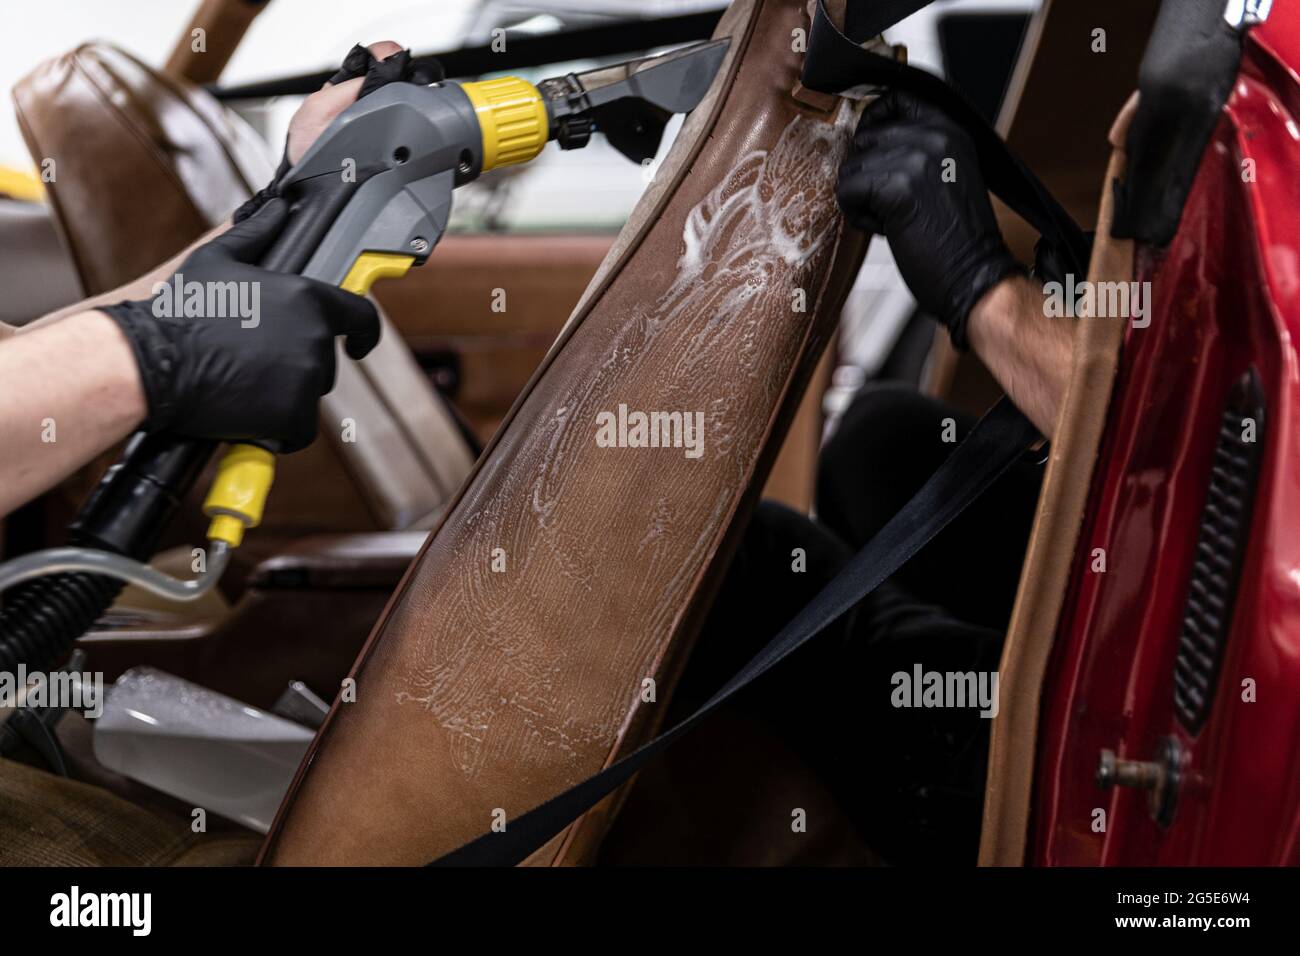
[1031,13,1300,865]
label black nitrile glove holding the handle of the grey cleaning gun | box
[100,199,380,451]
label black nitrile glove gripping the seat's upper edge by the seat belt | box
[836,91,1024,350]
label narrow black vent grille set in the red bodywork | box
[1174,368,1264,734]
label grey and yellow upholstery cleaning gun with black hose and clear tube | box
[0,39,729,670]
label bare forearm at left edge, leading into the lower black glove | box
[0,312,146,516]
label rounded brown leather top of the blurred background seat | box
[13,43,274,295]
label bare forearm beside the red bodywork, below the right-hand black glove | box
[967,277,1074,438]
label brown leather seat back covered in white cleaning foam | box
[263,0,865,864]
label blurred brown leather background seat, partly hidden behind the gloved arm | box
[13,43,473,532]
